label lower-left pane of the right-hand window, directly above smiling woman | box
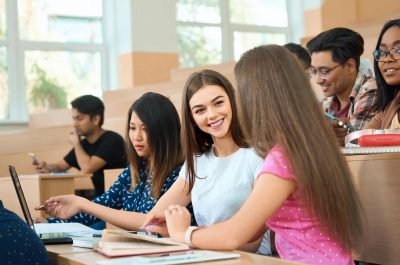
[178,26,222,67]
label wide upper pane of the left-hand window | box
[18,0,102,43]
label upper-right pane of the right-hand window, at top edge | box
[229,0,288,27]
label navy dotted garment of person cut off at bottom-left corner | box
[0,201,50,265]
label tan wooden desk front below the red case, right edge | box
[346,154,400,265]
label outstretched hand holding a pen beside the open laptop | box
[35,194,86,219]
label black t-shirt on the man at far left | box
[64,131,127,196]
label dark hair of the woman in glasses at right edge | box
[374,19,400,111]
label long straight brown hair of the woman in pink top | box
[235,45,364,251]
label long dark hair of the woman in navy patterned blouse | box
[126,92,183,199]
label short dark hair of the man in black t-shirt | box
[71,95,104,127]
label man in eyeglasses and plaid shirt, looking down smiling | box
[307,28,377,145]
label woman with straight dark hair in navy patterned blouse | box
[38,93,190,230]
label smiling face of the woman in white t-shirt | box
[189,85,232,138]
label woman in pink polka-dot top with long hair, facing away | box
[156,45,363,265]
